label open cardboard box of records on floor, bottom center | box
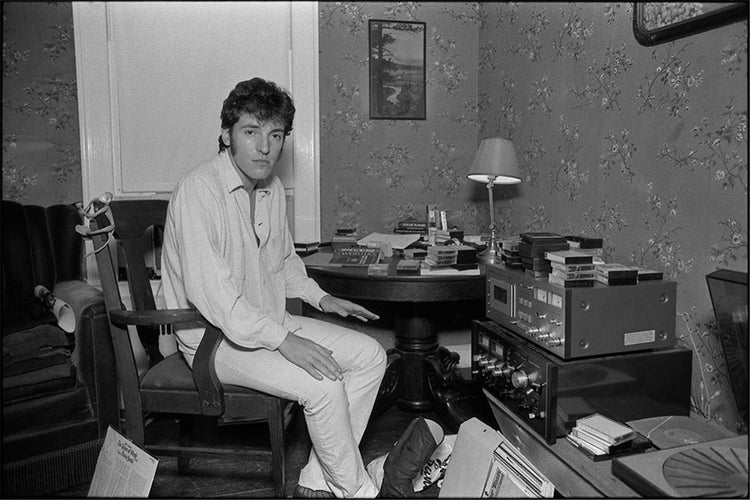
[438,418,555,498]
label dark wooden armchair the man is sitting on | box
[89,200,297,498]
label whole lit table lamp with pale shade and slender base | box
[467,137,521,264]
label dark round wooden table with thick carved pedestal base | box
[305,252,493,430]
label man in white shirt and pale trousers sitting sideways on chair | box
[162,78,386,498]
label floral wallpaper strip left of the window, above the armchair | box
[3,2,82,206]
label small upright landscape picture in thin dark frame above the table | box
[368,19,427,120]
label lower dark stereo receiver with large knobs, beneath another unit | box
[471,320,692,443]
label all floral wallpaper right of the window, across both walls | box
[319,2,748,430]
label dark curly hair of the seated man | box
[219,77,295,150]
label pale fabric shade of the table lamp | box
[467,137,521,184]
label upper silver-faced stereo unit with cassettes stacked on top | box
[487,264,677,359]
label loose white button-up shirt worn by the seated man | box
[162,151,326,362]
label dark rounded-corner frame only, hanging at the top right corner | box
[633,2,748,47]
